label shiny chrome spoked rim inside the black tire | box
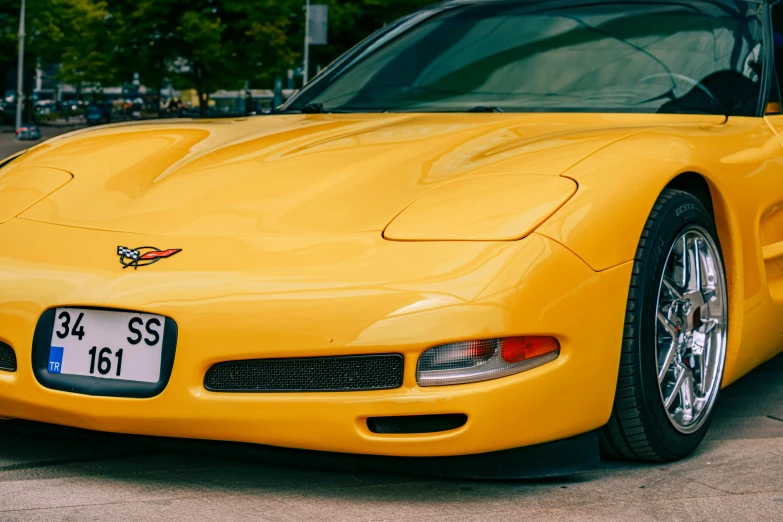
[655,225,728,434]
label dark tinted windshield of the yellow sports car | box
[283,0,763,116]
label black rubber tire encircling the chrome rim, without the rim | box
[600,189,725,462]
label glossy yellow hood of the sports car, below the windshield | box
[20,114,652,236]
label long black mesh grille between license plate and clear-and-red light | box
[204,354,403,392]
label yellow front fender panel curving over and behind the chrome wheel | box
[537,118,783,385]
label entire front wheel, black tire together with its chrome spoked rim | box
[601,189,728,462]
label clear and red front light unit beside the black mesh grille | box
[416,337,560,386]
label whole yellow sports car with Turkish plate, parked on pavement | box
[0,0,783,477]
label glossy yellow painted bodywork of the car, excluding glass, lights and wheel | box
[0,110,783,456]
